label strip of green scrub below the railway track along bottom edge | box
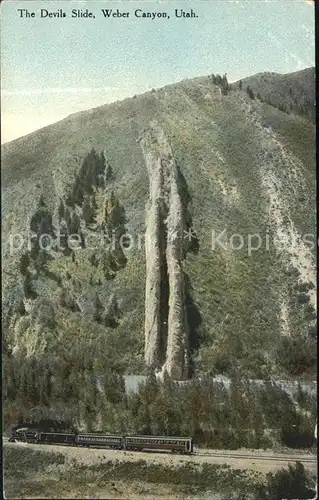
[4,447,314,500]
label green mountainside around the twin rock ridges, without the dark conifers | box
[2,69,315,377]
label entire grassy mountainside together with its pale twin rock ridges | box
[2,71,316,378]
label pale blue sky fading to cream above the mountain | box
[1,0,315,142]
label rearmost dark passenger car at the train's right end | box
[124,436,193,454]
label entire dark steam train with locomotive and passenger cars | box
[9,428,193,455]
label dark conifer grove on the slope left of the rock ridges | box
[20,149,126,311]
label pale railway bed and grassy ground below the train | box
[4,441,316,500]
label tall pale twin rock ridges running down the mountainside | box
[141,122,188,379]
